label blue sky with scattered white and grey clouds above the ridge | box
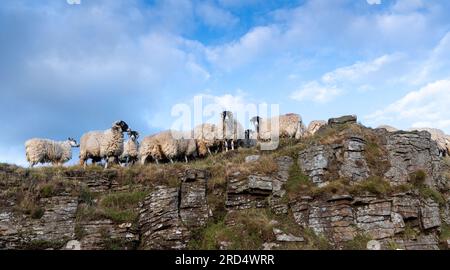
[0,0,450,164]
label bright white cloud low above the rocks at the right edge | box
[366,80,450,131]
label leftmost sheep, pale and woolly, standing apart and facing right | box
[25,138,79,168]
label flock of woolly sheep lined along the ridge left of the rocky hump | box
[25,111,316,168]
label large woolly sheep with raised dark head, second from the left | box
[80,121,130,169]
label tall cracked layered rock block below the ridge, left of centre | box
[138,170,209,249]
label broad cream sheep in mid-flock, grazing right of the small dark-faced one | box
[139,130,197,164]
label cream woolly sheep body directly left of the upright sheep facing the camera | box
[194,123,220,157]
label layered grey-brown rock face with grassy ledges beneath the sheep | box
[0,116,450,250]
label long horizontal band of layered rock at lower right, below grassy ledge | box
[291,194,441,249]
